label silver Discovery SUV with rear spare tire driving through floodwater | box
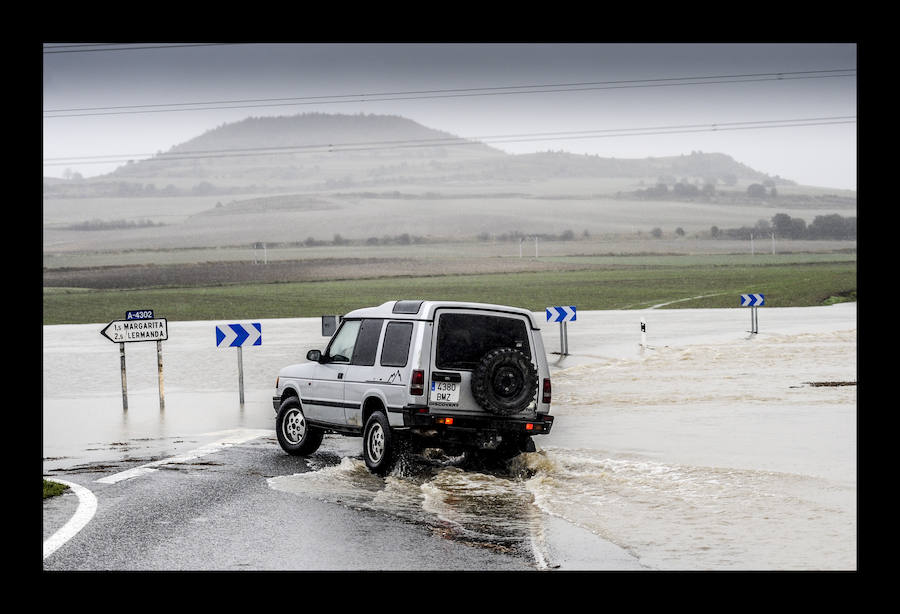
[272,300,553,474]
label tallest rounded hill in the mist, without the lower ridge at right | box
[110,113,505,183]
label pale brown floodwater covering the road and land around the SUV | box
[43,303,858,570]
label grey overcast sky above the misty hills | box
[42,42,857,190]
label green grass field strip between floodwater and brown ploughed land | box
[43,254,857,324]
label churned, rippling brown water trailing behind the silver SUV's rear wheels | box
[269,438,856,570]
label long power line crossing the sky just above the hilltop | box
[44,69,856,119]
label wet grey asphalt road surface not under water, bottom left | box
[43,436,535,571]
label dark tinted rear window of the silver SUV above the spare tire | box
[435,313,531,370]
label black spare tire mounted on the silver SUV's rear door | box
[472,348,538,416]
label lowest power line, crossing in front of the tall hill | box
[44,115,856,166]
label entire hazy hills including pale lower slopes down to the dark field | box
[43,113,856,254]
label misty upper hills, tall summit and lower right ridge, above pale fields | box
[44,113,792,198]
